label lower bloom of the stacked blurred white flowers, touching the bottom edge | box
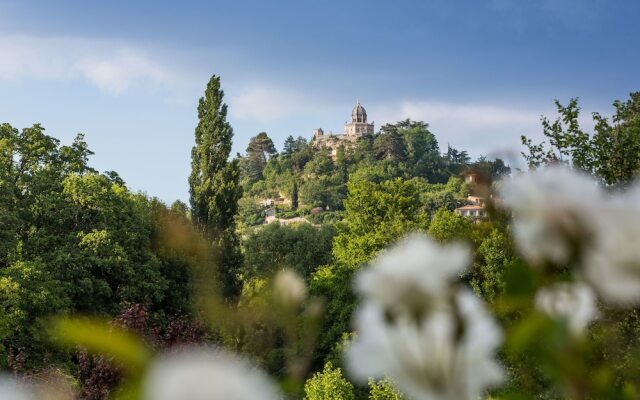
[347,290,503,400]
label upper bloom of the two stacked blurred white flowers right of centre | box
[356,234,471,307]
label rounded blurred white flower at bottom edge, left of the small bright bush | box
[143,347,280,400]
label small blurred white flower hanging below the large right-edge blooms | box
[535,283,598,335]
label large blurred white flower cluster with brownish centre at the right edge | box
[502,166,640,305]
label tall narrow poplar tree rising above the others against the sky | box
[189,75,242,297]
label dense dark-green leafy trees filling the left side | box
[0,124,190,371]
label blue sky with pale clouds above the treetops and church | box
[0,0,640,203]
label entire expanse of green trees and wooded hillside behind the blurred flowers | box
[0,76,640,399]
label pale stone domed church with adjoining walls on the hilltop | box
[313,100,373,158]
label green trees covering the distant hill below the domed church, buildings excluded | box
[239,120,496,220]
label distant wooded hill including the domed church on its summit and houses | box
[232,100,510,227]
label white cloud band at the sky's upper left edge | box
[0,36,178,94]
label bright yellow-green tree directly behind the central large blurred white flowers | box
[310,177,429,360]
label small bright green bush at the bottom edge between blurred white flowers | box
[304,363,355,400]
